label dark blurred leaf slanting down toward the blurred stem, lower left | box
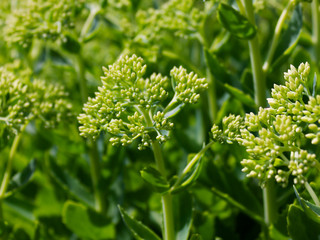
[50,160,95,208]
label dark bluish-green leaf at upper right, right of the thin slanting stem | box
[271,4,303,71]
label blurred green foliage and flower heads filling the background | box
[0,0,319,240]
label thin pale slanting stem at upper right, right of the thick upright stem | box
[263,0,296,73]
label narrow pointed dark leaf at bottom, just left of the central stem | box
[118,206,161,240]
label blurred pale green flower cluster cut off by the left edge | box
[0,66,71,142]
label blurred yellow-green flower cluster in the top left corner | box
[3,0,84,47]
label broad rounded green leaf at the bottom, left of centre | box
[62,201,115,240]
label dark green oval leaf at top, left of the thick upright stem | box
[218,3,257,39]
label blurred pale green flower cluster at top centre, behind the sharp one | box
[137,0,209,41]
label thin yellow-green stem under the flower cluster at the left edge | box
[0,124,27,220]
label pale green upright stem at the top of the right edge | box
[312,0,320,67]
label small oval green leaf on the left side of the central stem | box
[140,167,170,193]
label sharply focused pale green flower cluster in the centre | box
[78,55,207,149]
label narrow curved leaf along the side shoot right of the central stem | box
[171,154,204,193]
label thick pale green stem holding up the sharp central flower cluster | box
[152,141,175,240]
